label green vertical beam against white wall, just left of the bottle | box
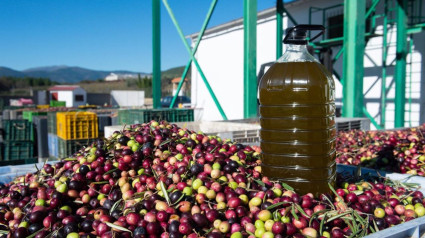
[243,0,258,118]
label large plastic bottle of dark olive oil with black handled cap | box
[259,25,336,196]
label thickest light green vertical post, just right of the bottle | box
[342,0,366,117]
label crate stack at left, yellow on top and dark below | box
[56,111,98,158]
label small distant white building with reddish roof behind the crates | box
[49,85,87,107]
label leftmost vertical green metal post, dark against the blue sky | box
[152,0,161,108]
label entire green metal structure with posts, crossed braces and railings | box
[152,0,425,125]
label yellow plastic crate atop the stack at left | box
[56,112,99,140]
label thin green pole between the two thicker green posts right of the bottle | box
[381,0,388,128]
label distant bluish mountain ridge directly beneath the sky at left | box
[0,65,148,84]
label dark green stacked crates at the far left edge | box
[0,119,37,166]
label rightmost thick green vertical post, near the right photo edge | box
[394,0,407,127]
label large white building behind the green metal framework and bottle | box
[188,0,425,128]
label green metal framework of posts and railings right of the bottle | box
[309,0,425,128]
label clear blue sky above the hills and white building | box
[0,0,276,73]
